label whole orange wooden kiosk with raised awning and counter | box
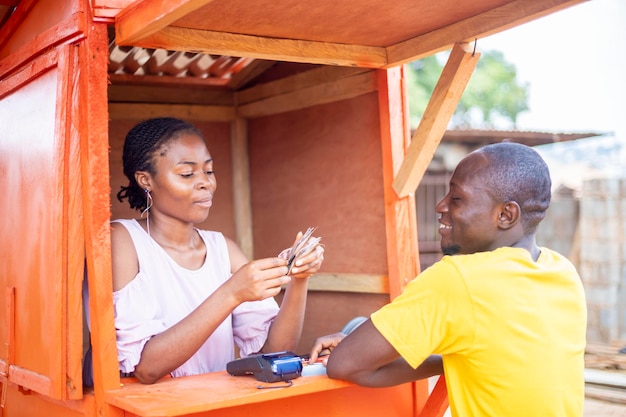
[0,0,580,417]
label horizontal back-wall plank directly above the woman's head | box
[109,103,235,122]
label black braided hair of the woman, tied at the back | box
[117,117,204,211]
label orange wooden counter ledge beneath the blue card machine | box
[105,371,415,417]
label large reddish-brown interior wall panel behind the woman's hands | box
[248,93,387,272]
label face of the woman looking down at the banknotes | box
[145,132,217,224]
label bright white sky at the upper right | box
[477,0,626,141]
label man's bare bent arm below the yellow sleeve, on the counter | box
[326,319,443,387]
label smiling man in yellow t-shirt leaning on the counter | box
[311,143,587,417]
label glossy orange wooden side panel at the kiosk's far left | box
[0,47,67,398]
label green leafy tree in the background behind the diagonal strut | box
[407,51,528,129]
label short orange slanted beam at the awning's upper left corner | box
[115,0,213,45]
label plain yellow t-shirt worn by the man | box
[372,247,587,417]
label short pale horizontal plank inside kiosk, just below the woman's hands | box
[309,273,389,294]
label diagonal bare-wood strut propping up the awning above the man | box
[393,44,480,197]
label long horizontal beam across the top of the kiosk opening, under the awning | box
[127,26,387,68]
